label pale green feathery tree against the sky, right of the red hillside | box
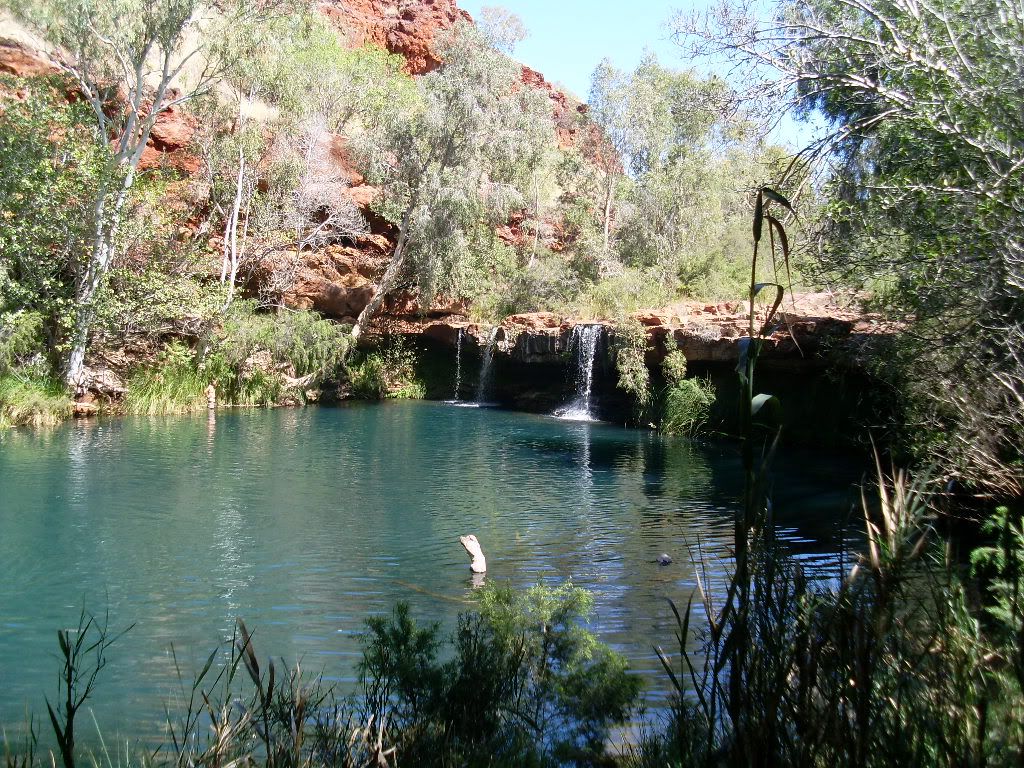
[590,55,771,293]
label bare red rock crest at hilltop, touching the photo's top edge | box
[319,0,473,75]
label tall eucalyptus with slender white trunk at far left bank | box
[4,0,290,386]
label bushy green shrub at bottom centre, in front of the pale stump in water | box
[360,584,639,766]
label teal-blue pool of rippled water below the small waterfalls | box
[0,402,859,739]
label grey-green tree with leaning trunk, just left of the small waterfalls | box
[352,24,554,337]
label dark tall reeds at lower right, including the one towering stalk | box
[632,188,1024,768]
